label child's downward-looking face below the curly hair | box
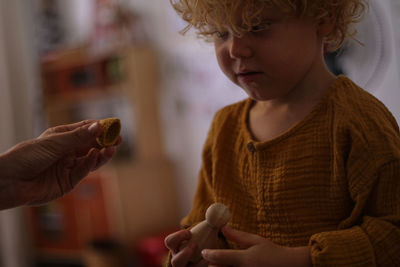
[214,8,323,101]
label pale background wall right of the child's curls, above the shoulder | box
[339,0,400,121]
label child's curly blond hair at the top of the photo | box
[170,0,368,51]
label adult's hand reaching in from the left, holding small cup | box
[0,120,121,209]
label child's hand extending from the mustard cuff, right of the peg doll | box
[202,226,312,267]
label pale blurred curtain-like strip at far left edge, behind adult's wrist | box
[0,0,38,267]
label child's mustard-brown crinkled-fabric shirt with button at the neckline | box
[177,76,400,266]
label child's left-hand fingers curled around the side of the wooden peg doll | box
[164,230,207,267]
